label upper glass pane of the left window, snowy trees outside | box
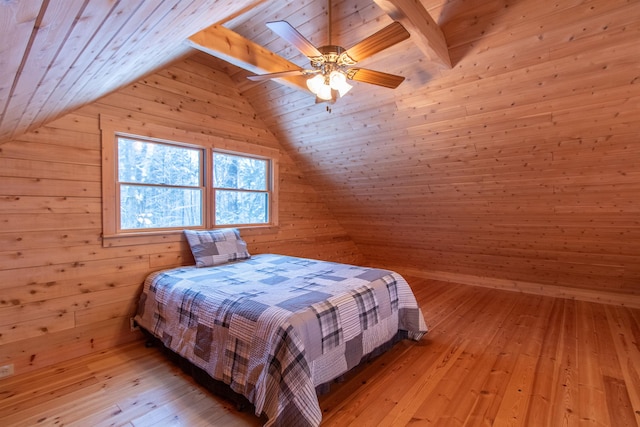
[118,138,201,187]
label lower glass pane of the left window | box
[120,184,202,230]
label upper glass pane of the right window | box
[213,153,268,191]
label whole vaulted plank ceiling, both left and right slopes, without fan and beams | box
[0,0,640,295]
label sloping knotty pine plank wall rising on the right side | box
[237,0,640,306]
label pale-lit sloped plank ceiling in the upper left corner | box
[0,0,261,142]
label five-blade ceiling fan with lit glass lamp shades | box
[247,0,410,102]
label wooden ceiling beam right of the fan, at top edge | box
[374,0,451,68]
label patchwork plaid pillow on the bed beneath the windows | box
[184,228,251,267]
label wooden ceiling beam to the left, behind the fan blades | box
[188,25,309,92]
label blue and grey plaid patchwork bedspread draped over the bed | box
[136,254,427,426]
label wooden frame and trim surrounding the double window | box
[100,114,280,247]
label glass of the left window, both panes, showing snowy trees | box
[117,137,203,230]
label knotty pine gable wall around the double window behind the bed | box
[0,55,362,373]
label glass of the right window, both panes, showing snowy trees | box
[213,152,269,225]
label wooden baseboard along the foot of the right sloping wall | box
[392,267,640,309]
